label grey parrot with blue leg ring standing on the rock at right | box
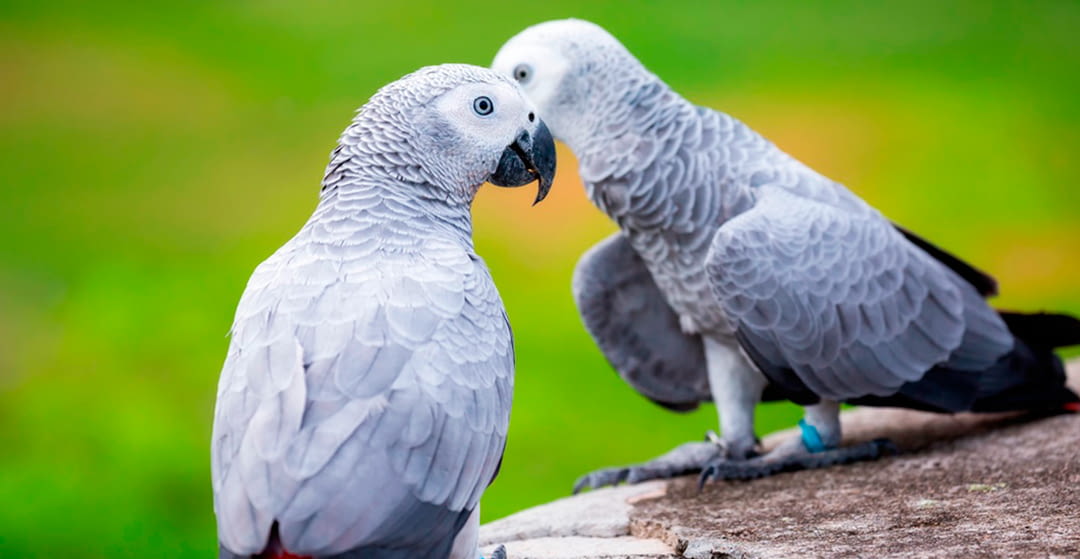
[492,19,1080,490]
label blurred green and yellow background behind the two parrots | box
[0,0,1080,558]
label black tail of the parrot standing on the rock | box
[973,311,1080,413]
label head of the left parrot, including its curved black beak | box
[342,64,555,202]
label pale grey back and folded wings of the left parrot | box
[213,238,513,557]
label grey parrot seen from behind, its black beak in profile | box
[211,65,555,559]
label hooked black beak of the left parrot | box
[489,120,555,205]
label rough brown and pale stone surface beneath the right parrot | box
[481,360,1080,559]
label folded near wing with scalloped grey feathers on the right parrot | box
[706,187,1012,400]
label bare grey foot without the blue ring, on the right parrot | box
[573,433,726,494]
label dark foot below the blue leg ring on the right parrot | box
[698,438,897,489]
